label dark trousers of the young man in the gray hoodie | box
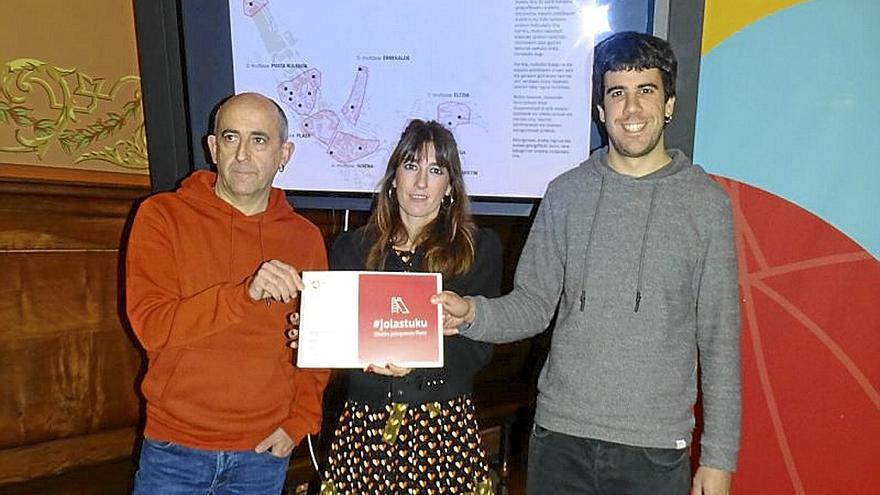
[528,425,691,495]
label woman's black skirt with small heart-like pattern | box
[321,396,494,495]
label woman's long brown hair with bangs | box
[367,119,475,277]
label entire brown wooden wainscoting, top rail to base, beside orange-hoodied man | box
[0,179,147,483]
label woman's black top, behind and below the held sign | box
[330,227,502,407]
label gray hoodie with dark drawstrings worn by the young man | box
[462,149,740,471]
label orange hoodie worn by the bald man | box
[126,171,329,450]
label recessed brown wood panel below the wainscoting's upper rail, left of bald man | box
[0,251,141,448]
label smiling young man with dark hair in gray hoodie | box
[434,32,740,495]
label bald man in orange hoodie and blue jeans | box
[126,93,329,495]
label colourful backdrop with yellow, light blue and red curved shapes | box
[694,0,880,495]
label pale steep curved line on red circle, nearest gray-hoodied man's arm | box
[725,177,806,495]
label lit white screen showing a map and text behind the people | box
[229,0,592,197]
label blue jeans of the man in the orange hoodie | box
[134,438,290,495]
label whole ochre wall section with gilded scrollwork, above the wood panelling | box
[0,0,148,184]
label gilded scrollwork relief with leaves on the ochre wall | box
[0,58,148,171]
